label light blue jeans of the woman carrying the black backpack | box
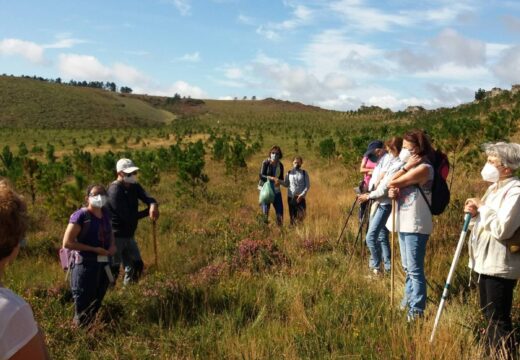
[399,232,430,317]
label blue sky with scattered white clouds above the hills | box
[0,0,520,110]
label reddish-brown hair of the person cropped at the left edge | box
[0,178,29,260]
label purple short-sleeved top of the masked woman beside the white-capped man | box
[69,208,112,258]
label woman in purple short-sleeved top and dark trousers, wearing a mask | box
[63,185,116,327]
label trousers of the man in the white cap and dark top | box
[112,237,144,285]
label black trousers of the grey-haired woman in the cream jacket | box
[479,275,516,357]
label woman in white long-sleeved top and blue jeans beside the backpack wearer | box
[358,137,403,275]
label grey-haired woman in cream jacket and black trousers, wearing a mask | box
[464,142,520,359]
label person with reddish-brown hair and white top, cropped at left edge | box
[0,179,49,360]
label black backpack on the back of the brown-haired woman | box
[416,150,450,215]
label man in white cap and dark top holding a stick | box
[108,159,159,285]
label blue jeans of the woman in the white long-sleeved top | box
[366,204,392,271]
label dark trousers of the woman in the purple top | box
[70,260,109,327]
